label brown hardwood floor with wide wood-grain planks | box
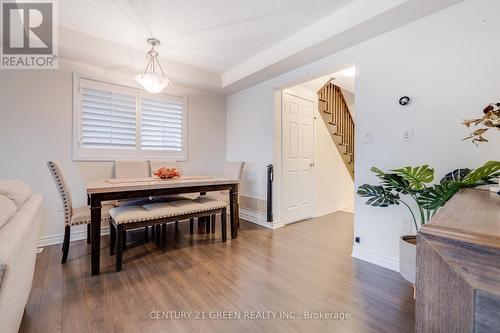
[20,212,415,333]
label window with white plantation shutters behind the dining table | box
[73,77,187,160]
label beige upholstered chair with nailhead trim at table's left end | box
[47,161,113,264]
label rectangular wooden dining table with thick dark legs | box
[87,177,239,275]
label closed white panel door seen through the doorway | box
[282,93,314,223]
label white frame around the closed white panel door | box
[280,87,318,225]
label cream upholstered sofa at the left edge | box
[0,181,42,333]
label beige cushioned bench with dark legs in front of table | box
[109,196,228,272]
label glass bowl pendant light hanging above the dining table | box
[135,38,172,94]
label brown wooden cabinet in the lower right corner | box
[416,189,500,333]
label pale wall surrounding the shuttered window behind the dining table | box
[0,63,226,242]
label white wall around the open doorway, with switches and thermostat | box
[227,0,500,269]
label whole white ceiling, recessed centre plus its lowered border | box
[57,0,463,94]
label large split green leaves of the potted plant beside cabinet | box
[358,161,500,230]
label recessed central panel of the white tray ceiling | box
[58,0,353,73]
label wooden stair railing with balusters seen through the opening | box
[318,78,354,180]
